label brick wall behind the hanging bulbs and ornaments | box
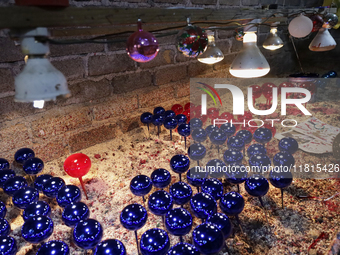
[0,0,340,161]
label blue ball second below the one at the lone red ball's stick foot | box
[73,219,103,250]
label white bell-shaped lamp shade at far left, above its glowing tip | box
[14,58,70,102]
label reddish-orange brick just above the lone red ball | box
[69,124,117,152]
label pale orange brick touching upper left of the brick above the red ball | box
[32,108,91,138]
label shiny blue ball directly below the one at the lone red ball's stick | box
[62,202,90,227]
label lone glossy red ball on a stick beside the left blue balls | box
[64,153,91,178]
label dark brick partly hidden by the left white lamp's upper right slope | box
[52,58,85,80]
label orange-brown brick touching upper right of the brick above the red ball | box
[93,95,138,121]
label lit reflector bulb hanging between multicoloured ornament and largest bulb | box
[197,31,224,65]
